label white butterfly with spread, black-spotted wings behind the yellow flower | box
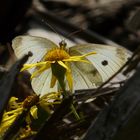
[12,36,130,96]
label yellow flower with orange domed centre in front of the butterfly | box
[21,46,96,91]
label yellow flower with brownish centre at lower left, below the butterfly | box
[0,92,61,136]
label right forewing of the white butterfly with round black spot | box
[69,44,129,84]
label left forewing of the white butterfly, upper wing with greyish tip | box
[12,35,57,67]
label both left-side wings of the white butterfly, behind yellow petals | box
[12,36,57,96]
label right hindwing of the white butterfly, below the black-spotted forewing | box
[71,62,102,90]
